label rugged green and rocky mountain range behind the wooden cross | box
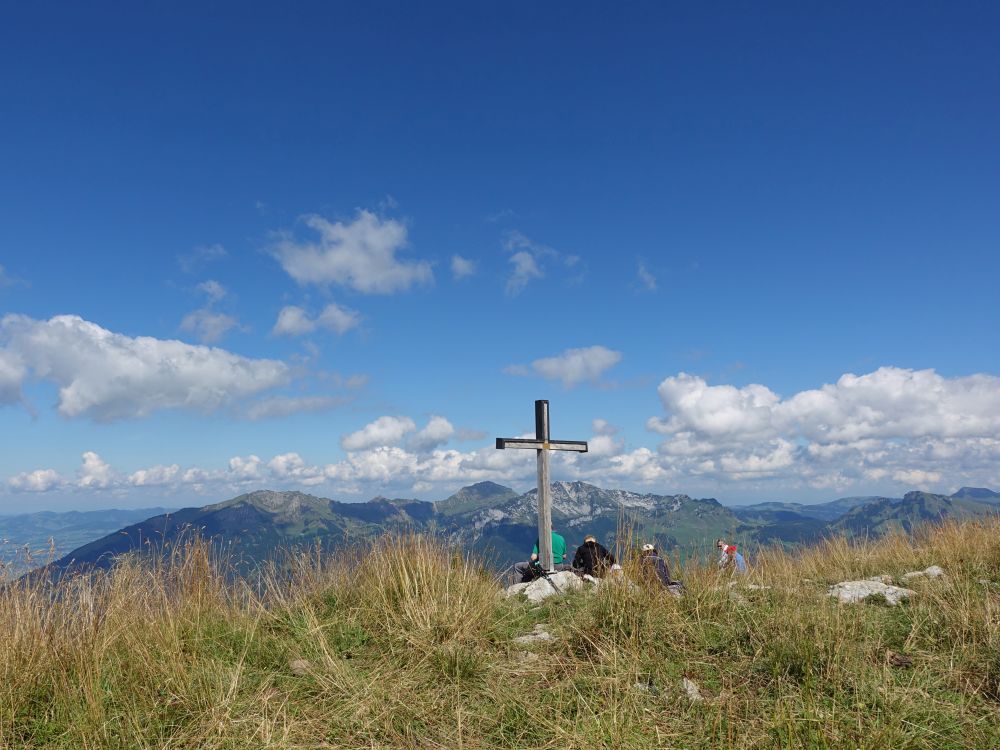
[13,482,1000,570]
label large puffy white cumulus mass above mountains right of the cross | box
[647,367,1000,488]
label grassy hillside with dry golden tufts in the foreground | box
[0,519,1000,750]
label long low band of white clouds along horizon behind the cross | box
[8,368,1000,499]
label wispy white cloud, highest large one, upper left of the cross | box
[272,210,433,294]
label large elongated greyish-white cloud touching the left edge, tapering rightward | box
[0,315,289,421]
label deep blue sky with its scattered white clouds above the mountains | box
[0,2,1000,512]
